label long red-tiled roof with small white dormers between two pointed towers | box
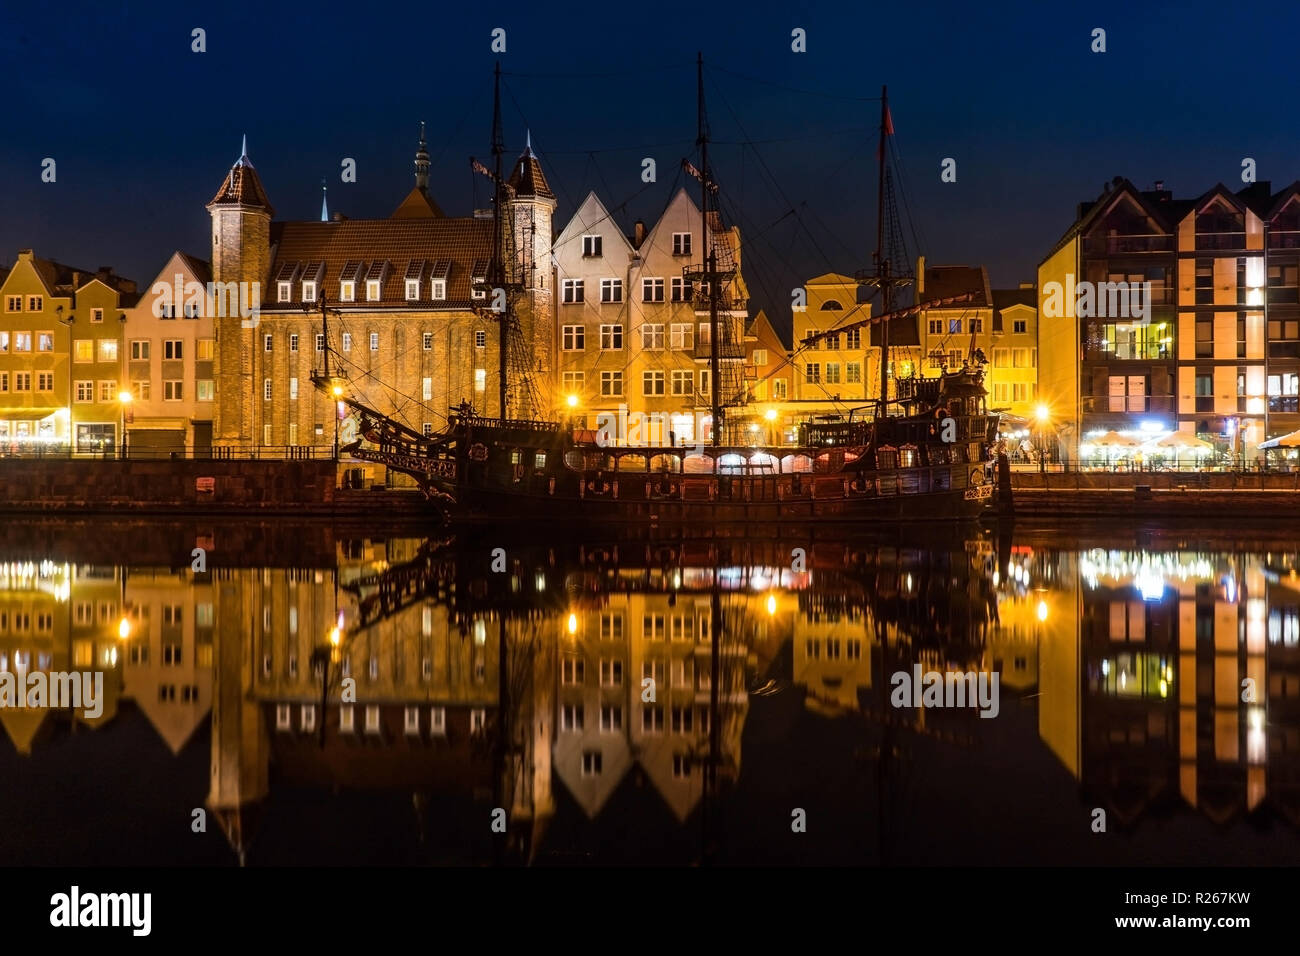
[263,217,494,311]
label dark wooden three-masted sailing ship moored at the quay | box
[313,57,998,523]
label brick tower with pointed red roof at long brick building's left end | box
[208,137,274,446]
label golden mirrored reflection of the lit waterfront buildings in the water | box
[0,522,1300,861]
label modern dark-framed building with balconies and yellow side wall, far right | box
[1039,177,1300,460]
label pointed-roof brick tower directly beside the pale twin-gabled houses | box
[507,133,556,403]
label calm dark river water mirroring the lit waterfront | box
[0,522,1300,865]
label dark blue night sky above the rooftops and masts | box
[0,1,1300,325]
